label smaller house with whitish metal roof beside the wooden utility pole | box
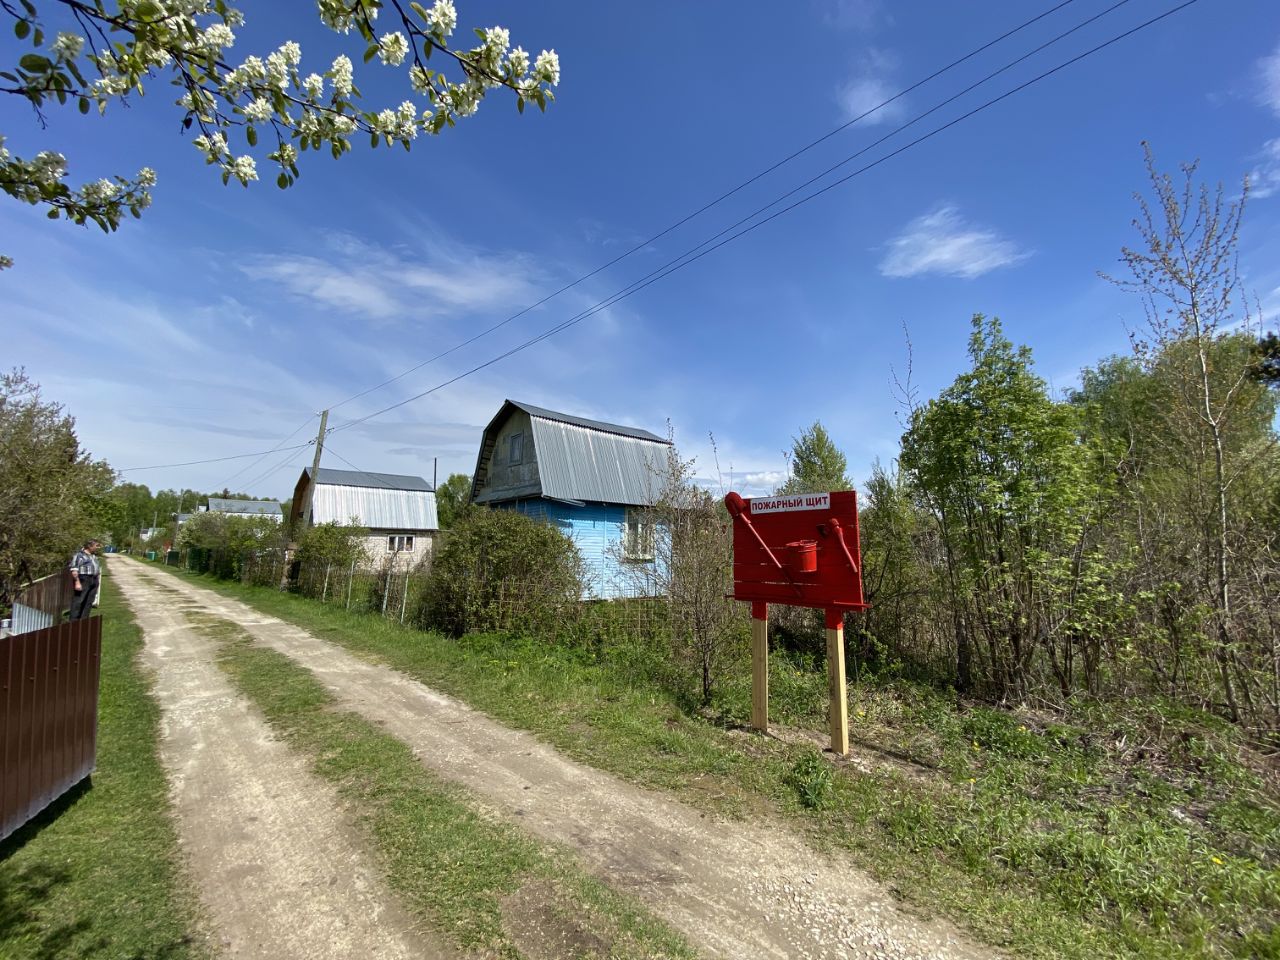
[289,467,440,568]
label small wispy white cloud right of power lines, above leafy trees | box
[879,204,1030,280]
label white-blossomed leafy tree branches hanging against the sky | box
[0,0,559,268]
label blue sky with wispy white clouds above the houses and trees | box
[0,0,1280,497]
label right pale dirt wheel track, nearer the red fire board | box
[111,559,996,960]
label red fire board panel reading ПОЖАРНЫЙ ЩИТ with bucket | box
[724,490,867,611]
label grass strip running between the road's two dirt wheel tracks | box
[187,613,695,960]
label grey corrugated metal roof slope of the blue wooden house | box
[530,422,669,506]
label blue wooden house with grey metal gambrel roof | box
[471,399,671,598]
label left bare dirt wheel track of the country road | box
[110,558,454,960]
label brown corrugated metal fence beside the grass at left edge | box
[0,617,102,840]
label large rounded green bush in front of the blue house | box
[419,509,585,636]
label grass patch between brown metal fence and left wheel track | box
[0,568,209,960]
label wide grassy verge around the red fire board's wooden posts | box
[160,563,1280,960]
